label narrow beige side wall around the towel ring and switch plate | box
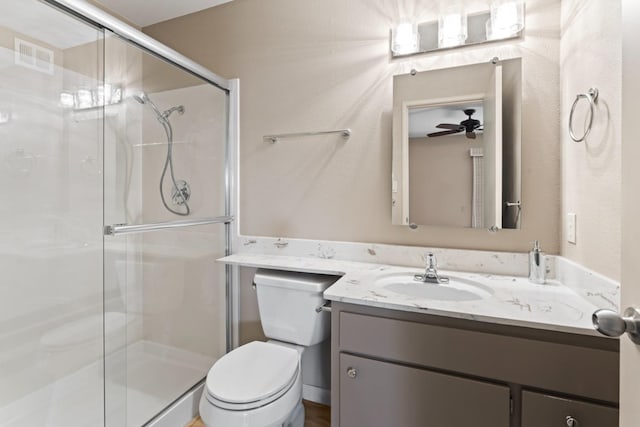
[561,0,622,280]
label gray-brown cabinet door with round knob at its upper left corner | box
[339,353,510,427]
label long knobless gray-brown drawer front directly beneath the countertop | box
[339,311,619,402]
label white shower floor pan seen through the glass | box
[0,341,215,427]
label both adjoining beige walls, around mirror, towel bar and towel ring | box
[145,0,620,278]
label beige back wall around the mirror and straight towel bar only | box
[145,0,560,253]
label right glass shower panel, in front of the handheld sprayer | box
[104,33,228,427]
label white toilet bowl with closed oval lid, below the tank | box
[200,341,304,427]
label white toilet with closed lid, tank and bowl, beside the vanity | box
[200,269,338,427]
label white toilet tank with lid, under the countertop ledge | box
[254,269,340,346]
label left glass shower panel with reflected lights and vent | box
[0,0,104,427]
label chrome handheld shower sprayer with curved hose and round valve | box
[132,92,191,216]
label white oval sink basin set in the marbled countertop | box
[375,273,493,301]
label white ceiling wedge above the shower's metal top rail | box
[96,0,232,27]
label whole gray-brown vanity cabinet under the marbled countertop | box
[331,301,618,427]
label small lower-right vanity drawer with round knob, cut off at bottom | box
[522,391,618,427]
